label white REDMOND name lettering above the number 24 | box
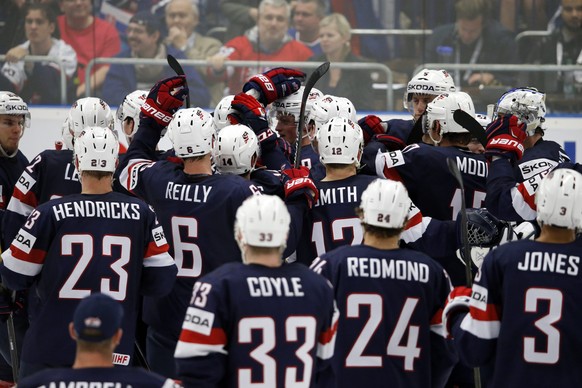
[347,257,429,283]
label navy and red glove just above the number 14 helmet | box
[228,93,277,150]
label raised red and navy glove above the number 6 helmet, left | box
[141,75,188,126]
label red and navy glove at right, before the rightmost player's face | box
[485,115,527,161]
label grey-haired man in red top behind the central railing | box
[208,0,313,93]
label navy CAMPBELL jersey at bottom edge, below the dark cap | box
[18,368,180,388]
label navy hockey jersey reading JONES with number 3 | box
[452,240,582,387]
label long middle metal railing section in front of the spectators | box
[85,58,394,110]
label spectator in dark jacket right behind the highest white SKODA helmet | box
[425,0,519,86]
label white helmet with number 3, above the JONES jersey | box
[536,168,582,229]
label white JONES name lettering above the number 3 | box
[517,252,580,276]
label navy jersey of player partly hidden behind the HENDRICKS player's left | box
[3,150,81,246]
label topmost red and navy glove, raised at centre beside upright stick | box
[243,67,305,106]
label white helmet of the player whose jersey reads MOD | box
[423,92,475,135]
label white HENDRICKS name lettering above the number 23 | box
[52,201,141,221]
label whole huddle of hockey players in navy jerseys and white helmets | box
[0,64,582,387]
